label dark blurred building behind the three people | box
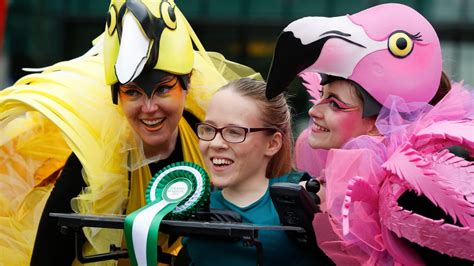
[0,0,474,131]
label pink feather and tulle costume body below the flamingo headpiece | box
[295,73,474,265]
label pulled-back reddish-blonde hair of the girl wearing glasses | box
[220,78,293,178]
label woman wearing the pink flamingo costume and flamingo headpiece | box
[266,4,474,265]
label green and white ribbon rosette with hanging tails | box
[124,162,210,265]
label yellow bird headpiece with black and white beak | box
[104,0,194,104]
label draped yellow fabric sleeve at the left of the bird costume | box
[0,56,128,265]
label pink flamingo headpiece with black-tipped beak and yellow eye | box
[267,4,442,115]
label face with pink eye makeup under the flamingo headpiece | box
[308,80,374,149]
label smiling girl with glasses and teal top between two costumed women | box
[184,78,317,265]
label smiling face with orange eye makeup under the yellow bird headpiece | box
[119,75,186,153]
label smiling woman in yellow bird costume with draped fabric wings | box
[0,0,260,265]
